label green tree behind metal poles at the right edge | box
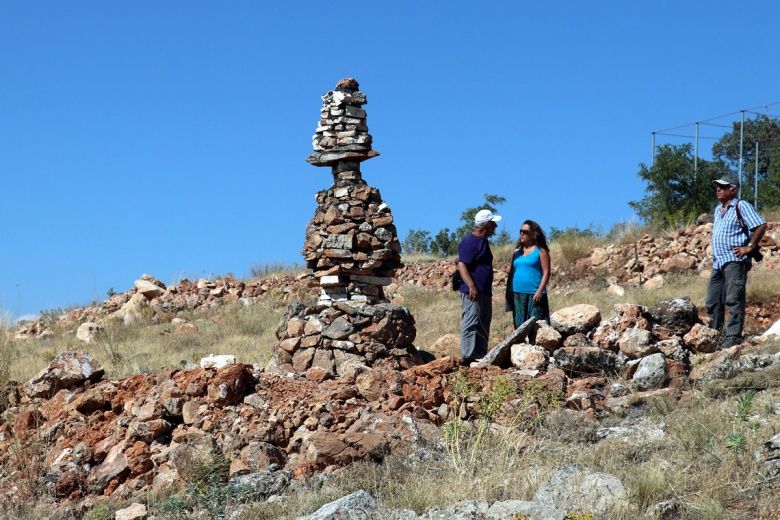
[712,115,780,207]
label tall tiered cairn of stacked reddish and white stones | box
[274,78,417,380]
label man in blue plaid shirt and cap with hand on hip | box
[706,176,766,348]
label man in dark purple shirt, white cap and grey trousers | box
[458,209,501,366]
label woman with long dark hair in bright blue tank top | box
[506,220,550,327]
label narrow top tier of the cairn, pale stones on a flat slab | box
[306,78,379,168]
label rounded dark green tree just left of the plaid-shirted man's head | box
[628,144,728,227]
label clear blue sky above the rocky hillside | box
[0,0,780,315]
